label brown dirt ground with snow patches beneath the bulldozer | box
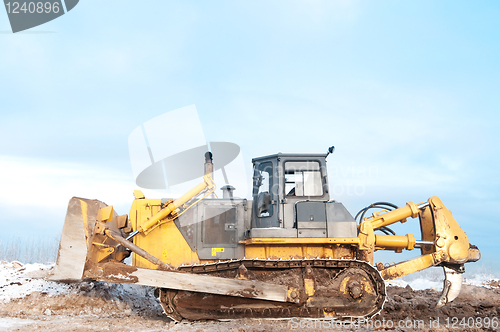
[0,283,500,332]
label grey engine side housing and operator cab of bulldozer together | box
[174,149,357,259]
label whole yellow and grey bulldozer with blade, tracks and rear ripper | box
[47,147,480,321]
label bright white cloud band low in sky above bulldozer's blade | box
[0,156,134,226]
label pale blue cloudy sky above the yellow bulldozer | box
[0,0,500,270]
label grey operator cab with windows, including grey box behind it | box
[250,150,357,238]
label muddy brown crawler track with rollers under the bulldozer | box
[158,259,386,321]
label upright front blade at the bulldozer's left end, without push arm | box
[46,197,107,282]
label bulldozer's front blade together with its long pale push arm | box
[46,197,298,302]
